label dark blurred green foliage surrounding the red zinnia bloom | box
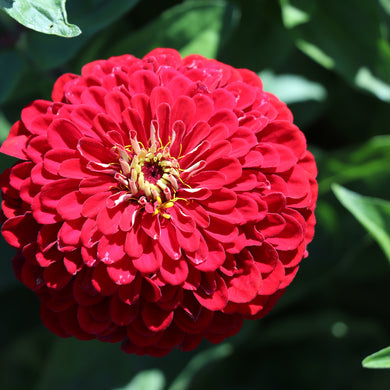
[0,0,390,390]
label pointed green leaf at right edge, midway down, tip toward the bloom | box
[332,184,390,261]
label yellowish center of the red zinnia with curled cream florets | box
[114,125,180,218]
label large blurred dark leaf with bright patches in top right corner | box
[279,0,390,102]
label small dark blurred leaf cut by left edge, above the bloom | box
[0,50,25,104]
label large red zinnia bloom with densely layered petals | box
[0,49,317,356]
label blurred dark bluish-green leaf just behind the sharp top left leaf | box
[23,0,138,70]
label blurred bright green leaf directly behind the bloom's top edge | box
[110,0,239,58]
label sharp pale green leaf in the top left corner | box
[0,0,81,37]
